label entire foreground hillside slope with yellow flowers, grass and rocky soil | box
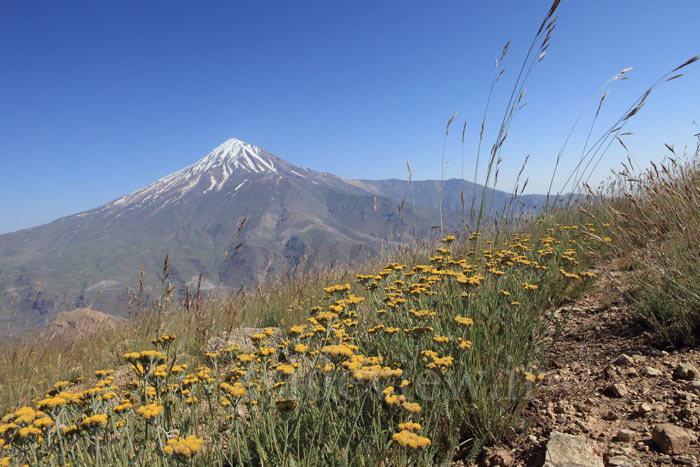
[0,149,700,467]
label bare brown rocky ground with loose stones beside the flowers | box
[477,270,700,467]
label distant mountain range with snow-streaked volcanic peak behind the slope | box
[0,139,544,335]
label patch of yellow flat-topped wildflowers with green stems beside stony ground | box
[0,225,603,467]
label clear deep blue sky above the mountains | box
[0,0,700,233]
